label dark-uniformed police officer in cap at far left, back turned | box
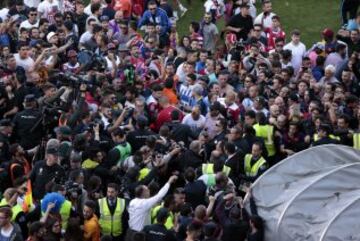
[13,94,43,150]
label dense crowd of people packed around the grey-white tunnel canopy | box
[0,0,360,241]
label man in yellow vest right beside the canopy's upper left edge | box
[244,142,267,182]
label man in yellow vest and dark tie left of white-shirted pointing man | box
[98,183,128,241]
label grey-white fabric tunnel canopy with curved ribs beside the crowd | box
[245,145,360,241]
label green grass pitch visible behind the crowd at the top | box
[176,0,341,48]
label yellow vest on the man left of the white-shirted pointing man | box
[98,198,125,237]
